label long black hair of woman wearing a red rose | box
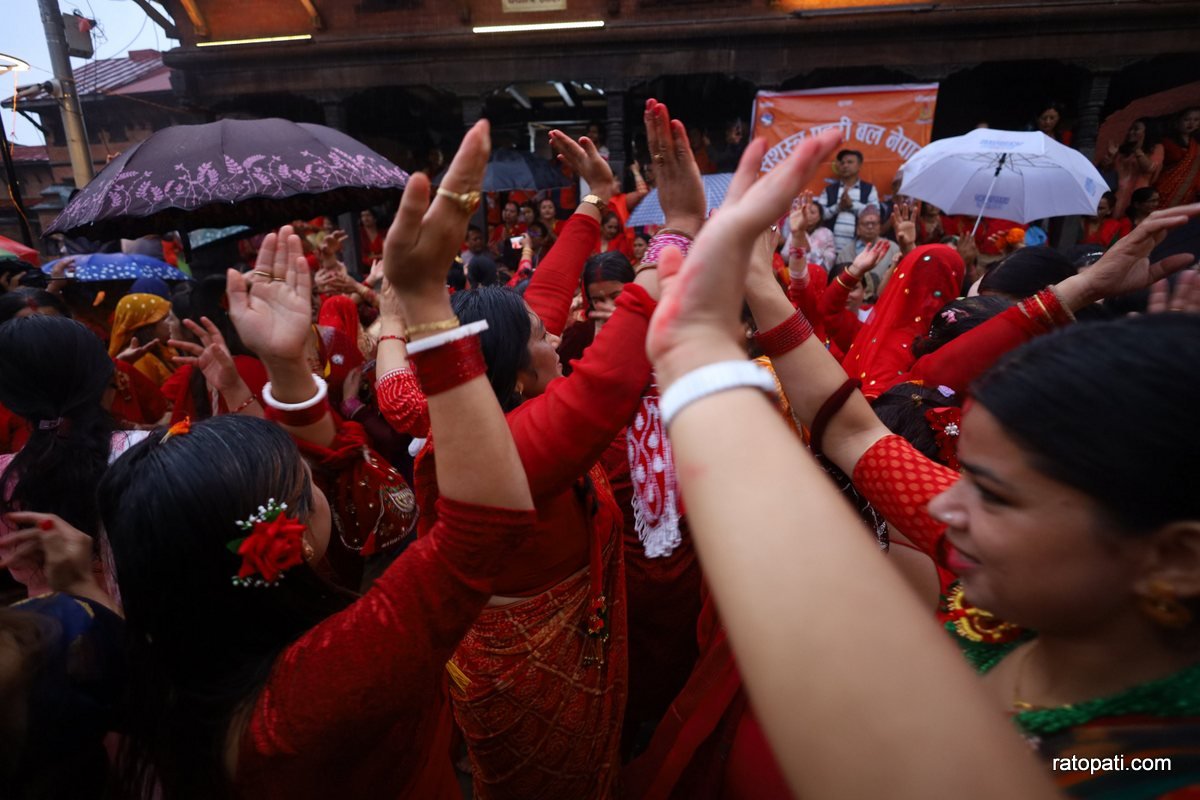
[98,415,352,799]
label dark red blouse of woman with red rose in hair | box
[234,498,534,800]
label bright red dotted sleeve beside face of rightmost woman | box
[853,434,960,561]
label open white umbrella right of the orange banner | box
[900,128,1108,235]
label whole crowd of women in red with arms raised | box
[0,100,1200,800]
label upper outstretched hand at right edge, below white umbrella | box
[1055,203,1200,311]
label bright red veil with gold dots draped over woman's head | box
[842,245,966,399]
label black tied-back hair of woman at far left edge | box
[0,315,113,536]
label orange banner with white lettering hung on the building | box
[754,83,937,197]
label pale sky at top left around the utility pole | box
[0,0,179,144]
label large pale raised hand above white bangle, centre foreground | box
[646,131,841,385]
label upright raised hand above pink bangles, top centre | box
[644,98,708,236]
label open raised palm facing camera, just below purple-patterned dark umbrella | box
[226,225,312,362]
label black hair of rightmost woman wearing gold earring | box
[971,314,1200,534]
